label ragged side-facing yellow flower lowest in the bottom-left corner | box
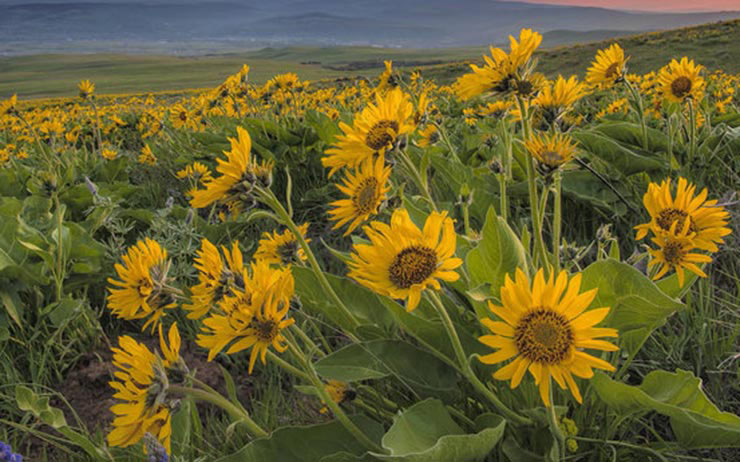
[108,323,187,453]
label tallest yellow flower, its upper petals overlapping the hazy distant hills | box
[453,29,542,100]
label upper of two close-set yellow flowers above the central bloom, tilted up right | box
[321,88,415,177]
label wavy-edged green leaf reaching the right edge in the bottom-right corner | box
[592,369,740,448]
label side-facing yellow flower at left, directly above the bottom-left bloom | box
[108,238,175,330]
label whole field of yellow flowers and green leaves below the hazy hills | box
[0,22,740,462]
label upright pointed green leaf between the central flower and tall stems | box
[465,207,527,296]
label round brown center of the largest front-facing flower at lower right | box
[514,307,574,364]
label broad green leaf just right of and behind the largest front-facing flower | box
[581,259,683,352]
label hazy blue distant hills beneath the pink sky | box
[0,0,740,55]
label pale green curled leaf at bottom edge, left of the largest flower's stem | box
[373,399,505,462]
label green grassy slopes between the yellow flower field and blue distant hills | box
[0,20,740,98]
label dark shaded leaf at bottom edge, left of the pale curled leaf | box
[216,416,383,462]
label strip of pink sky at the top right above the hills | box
[525,0,740,11]
